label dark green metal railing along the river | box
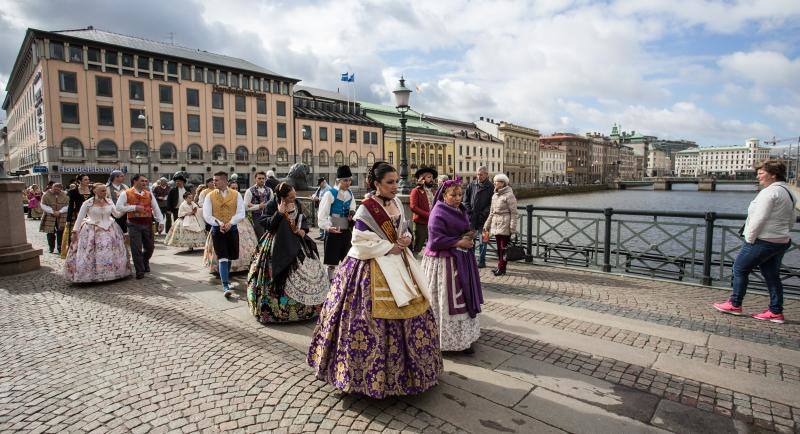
[500,205,800,295]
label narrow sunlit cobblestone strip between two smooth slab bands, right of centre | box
[482,301,800,384]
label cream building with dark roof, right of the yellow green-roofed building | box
[424,116,503,182]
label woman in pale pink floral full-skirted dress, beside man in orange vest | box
[64,183,131,283]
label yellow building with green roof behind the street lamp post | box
[359,101,455,181]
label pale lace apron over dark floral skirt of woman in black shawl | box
[283,215,331,306]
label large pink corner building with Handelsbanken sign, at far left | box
[2,27,300,186]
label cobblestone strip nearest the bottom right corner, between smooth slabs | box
[478,330,800,433]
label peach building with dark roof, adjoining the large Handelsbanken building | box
[294,86,383,187]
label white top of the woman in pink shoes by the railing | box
[744,181,797,244]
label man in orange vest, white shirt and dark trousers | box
[117,174,164,279]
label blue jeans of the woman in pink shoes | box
[730,240,792,314]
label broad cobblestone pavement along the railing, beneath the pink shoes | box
[481,264,800,350]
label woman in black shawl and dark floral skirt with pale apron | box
[247,182,330,323]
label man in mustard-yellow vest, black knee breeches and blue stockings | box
[203,172,245,298]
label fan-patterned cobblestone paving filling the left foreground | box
[0,225,458,433]
